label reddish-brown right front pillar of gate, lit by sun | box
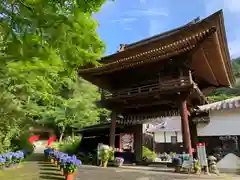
[180,100,192,156]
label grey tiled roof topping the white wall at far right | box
[198,96,240,111]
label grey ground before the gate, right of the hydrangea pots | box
[77,166,240,180]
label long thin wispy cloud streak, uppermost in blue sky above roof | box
[125,8,169,16]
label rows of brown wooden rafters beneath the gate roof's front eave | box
[79,27,216,75]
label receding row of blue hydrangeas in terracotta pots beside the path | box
[44,148,81,180]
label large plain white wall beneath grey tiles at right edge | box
[197,108,240,136]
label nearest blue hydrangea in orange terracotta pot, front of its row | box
[64,155,81,180]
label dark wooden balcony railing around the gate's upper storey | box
[103,77,192,99]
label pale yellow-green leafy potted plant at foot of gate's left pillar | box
[99,145,114,167]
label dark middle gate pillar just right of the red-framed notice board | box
[134,124,143,163]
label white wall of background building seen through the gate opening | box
[154,132,182,143]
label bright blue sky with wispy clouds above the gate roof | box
[95,0,240,58]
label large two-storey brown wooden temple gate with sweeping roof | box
[79,11,234,161]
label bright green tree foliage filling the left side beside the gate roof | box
[0,0,109,148]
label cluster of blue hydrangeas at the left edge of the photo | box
[0,151,24,170]
